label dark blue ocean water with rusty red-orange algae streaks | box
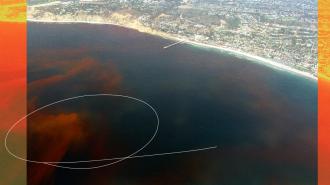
[28,23,317,185]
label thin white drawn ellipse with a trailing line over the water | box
[4,94,217,170]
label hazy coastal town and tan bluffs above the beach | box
[28,0,318,77]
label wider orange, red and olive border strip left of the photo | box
[0,0,27,185]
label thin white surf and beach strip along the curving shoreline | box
[27,18,318,81]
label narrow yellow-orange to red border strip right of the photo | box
[318,0,330,185]
